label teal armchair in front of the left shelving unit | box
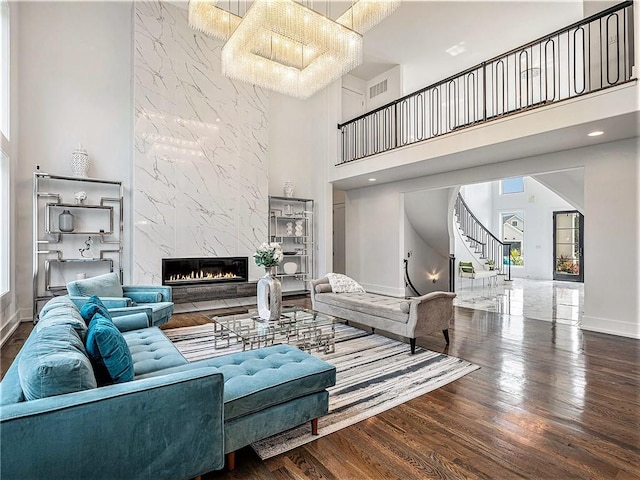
[67,272,173,327]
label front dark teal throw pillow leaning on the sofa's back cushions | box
[87,313,133,385]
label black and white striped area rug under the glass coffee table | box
[164,324,480,460]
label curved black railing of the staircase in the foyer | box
[455,193,513,280]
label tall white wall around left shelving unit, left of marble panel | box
[14,2,133,319]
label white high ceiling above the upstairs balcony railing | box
[351,0,584,89]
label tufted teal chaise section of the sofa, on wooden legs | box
[140,345,336,470]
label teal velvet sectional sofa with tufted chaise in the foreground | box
[0,297,335,480]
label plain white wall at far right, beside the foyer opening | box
[582,138,640,338]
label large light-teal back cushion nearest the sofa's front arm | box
[18,324,97,400]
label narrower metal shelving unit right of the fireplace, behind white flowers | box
[269,196,315,295]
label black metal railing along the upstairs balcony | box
[338,1,633,165]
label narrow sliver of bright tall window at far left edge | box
[0,0,11,296]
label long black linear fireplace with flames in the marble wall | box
[162,257,249,286]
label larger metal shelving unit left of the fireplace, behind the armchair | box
[33,172,123,319]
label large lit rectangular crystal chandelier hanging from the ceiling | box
[189,0,400,98]
